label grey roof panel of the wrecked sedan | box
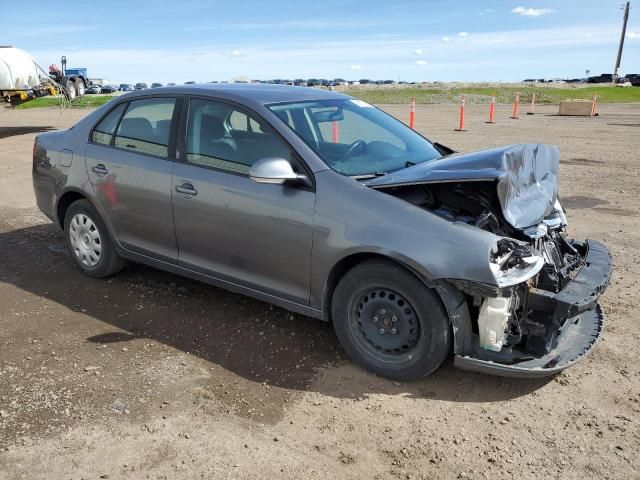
[120,83,351,105]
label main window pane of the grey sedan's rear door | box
[114,98,176,157]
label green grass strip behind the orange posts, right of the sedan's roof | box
[343,85,640,104]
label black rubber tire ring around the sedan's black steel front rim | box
[331,262,451,380]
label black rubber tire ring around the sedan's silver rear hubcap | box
[64,200,117,278]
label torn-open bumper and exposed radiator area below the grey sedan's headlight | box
[449,231,611,377]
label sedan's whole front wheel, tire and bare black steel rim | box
[331,260,451,381]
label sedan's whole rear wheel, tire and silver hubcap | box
[64,200,125,278]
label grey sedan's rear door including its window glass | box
[86,97,180,263]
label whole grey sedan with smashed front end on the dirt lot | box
[33,85,612,380]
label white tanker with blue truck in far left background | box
[0,46,89,105]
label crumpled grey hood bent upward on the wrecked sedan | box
[365,143,560,229]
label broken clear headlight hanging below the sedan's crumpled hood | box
[489,238,544,288]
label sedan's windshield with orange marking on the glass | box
[269,99,441,176]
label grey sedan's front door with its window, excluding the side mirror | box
[173,99,315,304]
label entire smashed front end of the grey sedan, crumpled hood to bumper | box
[369,145,612,377]
